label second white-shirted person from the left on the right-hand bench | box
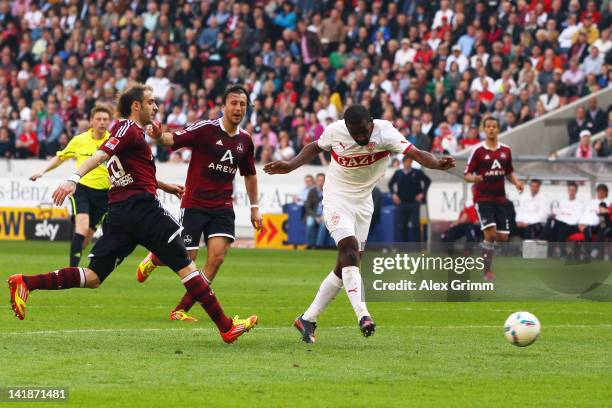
[542,181,584,256]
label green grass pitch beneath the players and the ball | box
[0,242,612,408]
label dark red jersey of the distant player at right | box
[465,143,514,203]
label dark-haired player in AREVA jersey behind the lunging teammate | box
[136,85,261,321]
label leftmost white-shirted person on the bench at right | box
[516,179,550,239]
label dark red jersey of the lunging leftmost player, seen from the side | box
[100,119,157,204]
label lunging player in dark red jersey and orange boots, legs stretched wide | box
[8,84,257,343]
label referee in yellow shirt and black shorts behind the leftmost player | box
[30,105,112,266]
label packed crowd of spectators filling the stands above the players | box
[0,0,612,164]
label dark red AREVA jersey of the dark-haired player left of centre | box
[173,119,255,209]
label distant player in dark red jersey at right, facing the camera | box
[464,117,523,281]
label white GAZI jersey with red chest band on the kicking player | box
[317,119,412,200]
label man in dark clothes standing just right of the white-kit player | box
[388,156,431,242]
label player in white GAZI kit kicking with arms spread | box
[264,105,455,343]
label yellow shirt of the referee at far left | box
[57,129,110,190]
